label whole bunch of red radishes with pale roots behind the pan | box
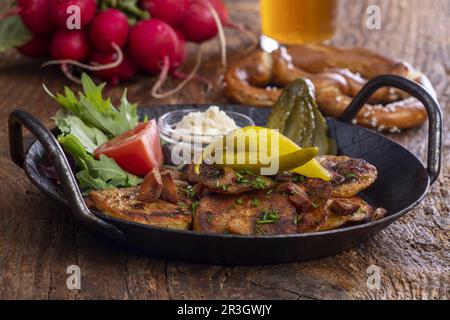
[4,0,256,98]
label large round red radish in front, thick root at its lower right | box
[128,19,180,74]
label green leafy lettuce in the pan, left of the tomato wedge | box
[44,74,142,193]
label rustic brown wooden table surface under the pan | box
[0,0,450,299]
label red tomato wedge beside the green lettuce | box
[94,120,164,176]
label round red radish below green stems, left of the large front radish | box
[89,9,130,52]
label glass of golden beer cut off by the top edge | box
[260,0,338,45]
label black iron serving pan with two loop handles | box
[9,75,442,265]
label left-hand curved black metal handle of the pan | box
[9,110,125,242]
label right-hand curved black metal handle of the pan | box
[339,75,442,184]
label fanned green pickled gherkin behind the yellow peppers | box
[267,78,330,155]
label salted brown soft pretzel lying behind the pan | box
[225,45,436,132]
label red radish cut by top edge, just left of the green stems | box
[45,0,97,29]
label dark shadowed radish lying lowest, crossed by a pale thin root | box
[91,51,138,84]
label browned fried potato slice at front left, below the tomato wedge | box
[89,187,192,230]
